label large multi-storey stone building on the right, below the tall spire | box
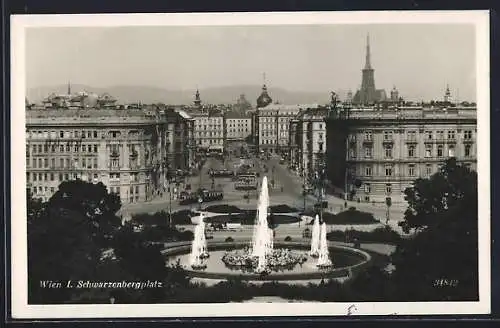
[326,107,477,202]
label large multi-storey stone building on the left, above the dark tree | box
[26,107,193,203]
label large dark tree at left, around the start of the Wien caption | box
[27,180,121,303]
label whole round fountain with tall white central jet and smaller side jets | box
[165,177,371,281]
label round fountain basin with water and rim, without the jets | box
[163,242,371,281]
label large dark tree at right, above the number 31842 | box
[393,158,478,300]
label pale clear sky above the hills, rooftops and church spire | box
[25,24,476,101]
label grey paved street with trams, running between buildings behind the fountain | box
[119,143,405,228]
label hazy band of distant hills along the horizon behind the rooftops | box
[27,84,345,106]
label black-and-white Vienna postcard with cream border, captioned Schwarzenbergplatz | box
[10,11,490,319]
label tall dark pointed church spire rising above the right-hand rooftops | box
[352,35,387,104]
